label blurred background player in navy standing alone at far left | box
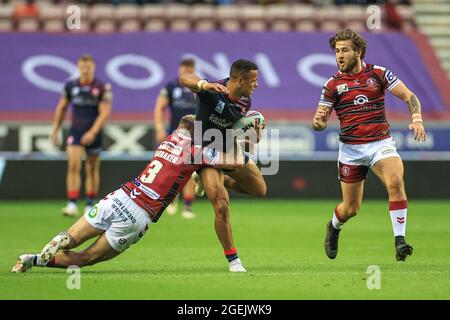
[51,55,112,216]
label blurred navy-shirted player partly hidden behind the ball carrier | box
[154,58,197,219]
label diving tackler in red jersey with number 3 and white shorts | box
[11,115,245,273]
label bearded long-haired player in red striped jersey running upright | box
[312,29,426,261]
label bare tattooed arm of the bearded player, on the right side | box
[391,82,426,141]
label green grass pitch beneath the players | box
[0,200,450,299]
